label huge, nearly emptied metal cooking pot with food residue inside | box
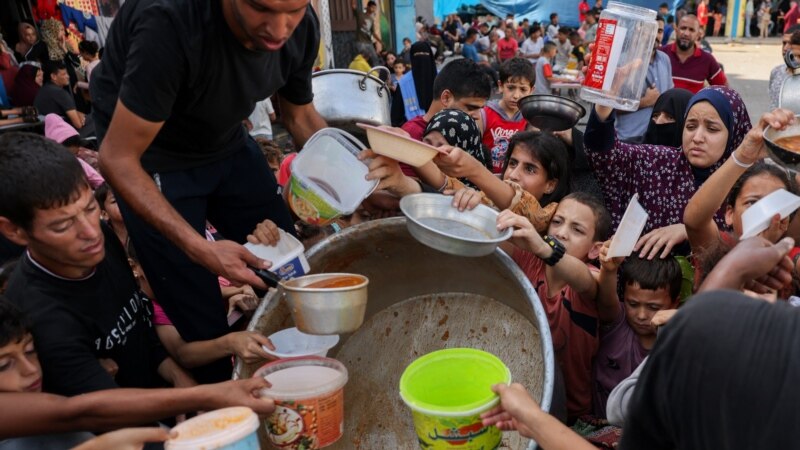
[234,217,563,450]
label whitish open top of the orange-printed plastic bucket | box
[253,356,347,400]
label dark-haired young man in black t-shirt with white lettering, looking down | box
[0,133,193,395]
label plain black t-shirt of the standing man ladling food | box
[91,0,319,172]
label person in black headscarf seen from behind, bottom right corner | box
[620,291,800,450]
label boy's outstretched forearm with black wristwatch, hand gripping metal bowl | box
[497,210,598,299]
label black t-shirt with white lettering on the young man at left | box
[5,226,166,396]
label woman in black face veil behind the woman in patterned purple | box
[642,88,692,147]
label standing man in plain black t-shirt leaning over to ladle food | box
[91,0,325,381]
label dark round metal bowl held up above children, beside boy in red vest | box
[517,94,586,131]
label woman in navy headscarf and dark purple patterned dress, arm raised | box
[584,86,751,257]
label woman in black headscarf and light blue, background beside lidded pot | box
[392,41,436,126]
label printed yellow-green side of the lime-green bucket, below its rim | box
[412,411,502,450]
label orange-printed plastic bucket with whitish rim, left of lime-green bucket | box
[253,357,347,450]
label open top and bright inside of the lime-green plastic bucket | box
[400,348,511,416]
